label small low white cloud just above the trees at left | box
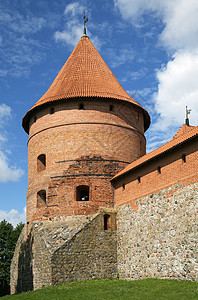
[0,207,26,227]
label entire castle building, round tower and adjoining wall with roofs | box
[11,35,198,293]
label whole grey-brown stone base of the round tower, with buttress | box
[11,209,117,294]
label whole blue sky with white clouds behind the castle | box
[0,0,198,226]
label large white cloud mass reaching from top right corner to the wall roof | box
[114,0,198,139]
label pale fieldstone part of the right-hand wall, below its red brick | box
[118,183,198,280]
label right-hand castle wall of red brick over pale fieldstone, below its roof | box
[113,138,198,280]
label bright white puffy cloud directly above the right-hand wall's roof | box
[155,51,198,130]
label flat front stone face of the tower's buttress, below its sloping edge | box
[52,215,117,283]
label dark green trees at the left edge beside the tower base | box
[0,220,24,296]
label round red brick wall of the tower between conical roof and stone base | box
[27,99,145,222]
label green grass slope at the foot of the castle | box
[1,279,198,300]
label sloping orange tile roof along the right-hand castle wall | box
[112,125,198,180]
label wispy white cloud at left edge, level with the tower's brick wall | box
[0,104,24,182]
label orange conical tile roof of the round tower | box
[23,36,150,132]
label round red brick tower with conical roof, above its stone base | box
[23,36,150,223]
